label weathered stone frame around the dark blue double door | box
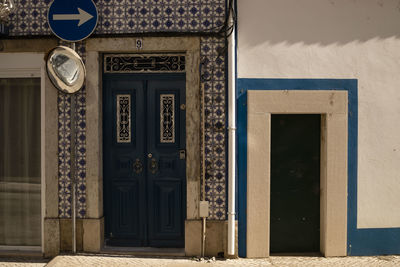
[83,37,200,252]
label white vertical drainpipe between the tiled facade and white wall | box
[228,8,236,256]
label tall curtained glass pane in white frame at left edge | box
[0,78,41,246]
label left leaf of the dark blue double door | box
[103,77,146,246]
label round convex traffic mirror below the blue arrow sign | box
[46,46,86,94]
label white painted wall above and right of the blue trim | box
[238,0,400,228]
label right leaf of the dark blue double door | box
[147,80,186,247]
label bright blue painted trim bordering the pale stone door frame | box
[237,78,400,257]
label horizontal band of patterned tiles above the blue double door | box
[10,0,225,36]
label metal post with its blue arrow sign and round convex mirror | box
[46,0,98,253]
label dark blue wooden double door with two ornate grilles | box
[103,74,186,247]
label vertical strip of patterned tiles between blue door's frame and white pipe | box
[200,37,226,219]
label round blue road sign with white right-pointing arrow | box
[47,0,98,42]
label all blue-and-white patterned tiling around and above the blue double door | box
[10,0,226,220]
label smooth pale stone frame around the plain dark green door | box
[246,90,348,258]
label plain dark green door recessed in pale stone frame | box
[270,115,321,253]
